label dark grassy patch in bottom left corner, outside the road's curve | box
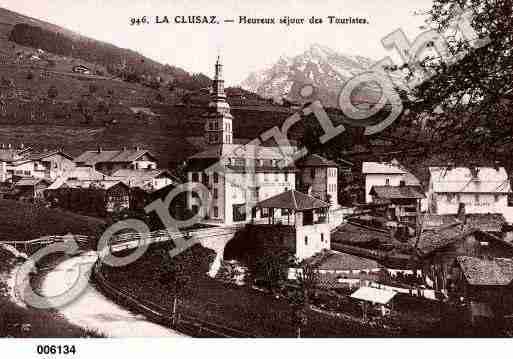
[0,248,103,338]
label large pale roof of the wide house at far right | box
[429,167,511,194]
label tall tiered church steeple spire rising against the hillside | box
[205,55,233,144]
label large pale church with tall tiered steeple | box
[187,57,338,225]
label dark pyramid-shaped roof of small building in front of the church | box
[256,190,330,211]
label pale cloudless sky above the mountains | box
[0,0,431,85]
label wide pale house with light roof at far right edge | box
[427,167,511,214]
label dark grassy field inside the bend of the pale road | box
[100,247,396,337]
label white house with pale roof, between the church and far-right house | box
[362,160,420,203]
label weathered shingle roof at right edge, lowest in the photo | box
[456,256,513,286]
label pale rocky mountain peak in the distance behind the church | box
[241,44,375,106]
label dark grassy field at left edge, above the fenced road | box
[0,200,104,241]
